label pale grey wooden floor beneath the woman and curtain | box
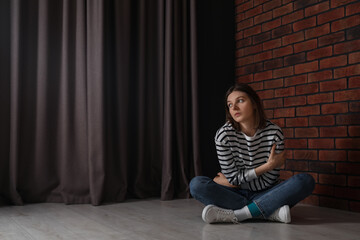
[0,199,360,240]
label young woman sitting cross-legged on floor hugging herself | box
[190,84,314,223]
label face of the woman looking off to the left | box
[227,91,255,124]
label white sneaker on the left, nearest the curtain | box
[202,205,238,223]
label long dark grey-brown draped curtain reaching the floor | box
[0,0,201,205]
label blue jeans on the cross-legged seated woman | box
[190,173,315,218]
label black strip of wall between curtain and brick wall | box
[196,0,235,177]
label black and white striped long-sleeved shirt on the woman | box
[215,121,284,191]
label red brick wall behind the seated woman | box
[235,0,360,212]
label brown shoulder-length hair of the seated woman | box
[225,83,266,131]
